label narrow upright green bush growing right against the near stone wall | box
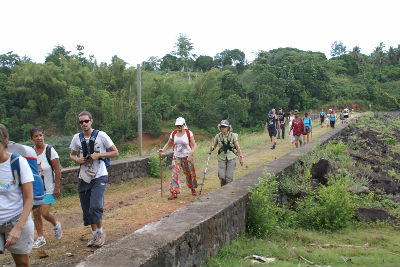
[246,173,282,240]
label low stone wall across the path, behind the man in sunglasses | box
[61,151,173,190]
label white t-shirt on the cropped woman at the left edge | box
[0,156,33,224]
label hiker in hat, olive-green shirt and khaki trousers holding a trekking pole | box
[210,120,243,186]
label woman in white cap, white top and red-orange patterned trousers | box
[158,117,197,200]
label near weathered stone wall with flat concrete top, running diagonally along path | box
[78,120,356,267]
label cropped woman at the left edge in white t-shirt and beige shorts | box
[0,124,34,266]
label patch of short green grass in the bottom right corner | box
[202,224,400,267]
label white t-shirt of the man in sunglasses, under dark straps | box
[69,131,114,179]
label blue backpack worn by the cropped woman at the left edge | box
[10,153,44,206]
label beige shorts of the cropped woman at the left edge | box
[0,215,34,254]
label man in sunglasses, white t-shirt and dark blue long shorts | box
[70,111,119,247]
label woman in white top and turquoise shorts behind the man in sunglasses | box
[30,126,62,248]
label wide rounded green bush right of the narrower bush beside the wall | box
[296,180,355,231]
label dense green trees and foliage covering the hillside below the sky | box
[0,39,400,143]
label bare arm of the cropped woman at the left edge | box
[5,182,33,247]
